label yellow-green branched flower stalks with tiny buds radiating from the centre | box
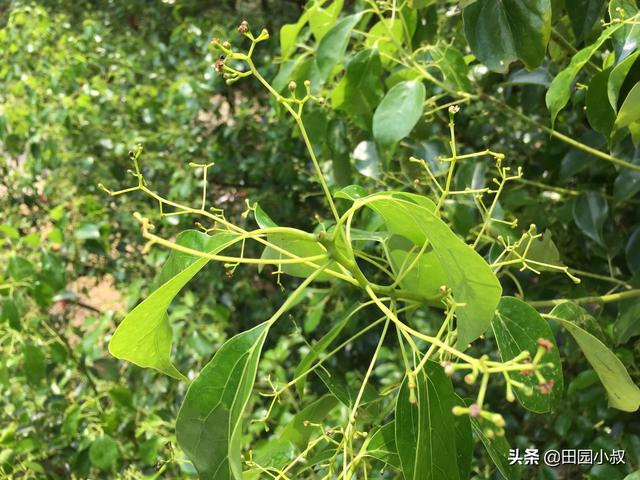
[99,20,638,479]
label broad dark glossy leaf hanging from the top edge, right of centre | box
[462,0,551,73]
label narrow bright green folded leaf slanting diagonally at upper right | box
[545,24,621,125]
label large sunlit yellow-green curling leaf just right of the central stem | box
[367,192,502,350]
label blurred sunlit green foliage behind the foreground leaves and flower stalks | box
[0,0,640,479]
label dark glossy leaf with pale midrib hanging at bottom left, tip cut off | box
[176,322,269,480]
